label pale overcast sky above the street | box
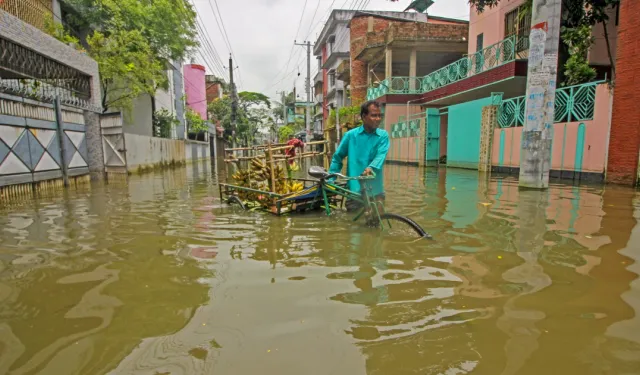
[192,0,469,100]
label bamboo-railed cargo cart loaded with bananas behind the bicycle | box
[219,140,339,215]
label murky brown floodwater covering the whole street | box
[0,165,640,375]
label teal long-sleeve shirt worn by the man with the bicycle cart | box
[329,126,389,196]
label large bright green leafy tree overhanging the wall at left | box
[65,0,198,111]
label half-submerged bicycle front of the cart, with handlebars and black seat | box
[280,166,431,238]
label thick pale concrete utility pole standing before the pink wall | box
[519,0,562,189]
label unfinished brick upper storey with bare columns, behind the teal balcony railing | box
[350,12,469,104]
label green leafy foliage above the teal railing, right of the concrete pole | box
[561,24,596,86]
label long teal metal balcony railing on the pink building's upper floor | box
[367,36,517,100]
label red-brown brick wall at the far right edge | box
[607,1,640,184]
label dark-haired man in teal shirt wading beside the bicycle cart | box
[329,101,389,211]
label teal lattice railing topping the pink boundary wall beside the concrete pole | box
[498,81,605,128]
